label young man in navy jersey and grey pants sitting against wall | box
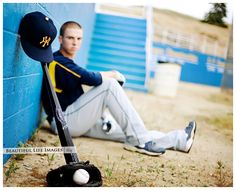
[43,21,196,156]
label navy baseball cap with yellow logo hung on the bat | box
[19,11,57,63]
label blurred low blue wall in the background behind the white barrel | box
[154,43,226,86]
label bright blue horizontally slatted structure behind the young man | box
[87,6,147,91]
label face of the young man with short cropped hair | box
[59,27,83,58]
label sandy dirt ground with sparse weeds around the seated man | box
[3,82,233,187]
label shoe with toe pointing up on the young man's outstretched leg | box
[185,121,197,153]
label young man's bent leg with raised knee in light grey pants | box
[65,79,151,146]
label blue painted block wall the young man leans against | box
[3,3,94,163]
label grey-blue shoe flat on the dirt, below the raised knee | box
[124,141,166,156]
